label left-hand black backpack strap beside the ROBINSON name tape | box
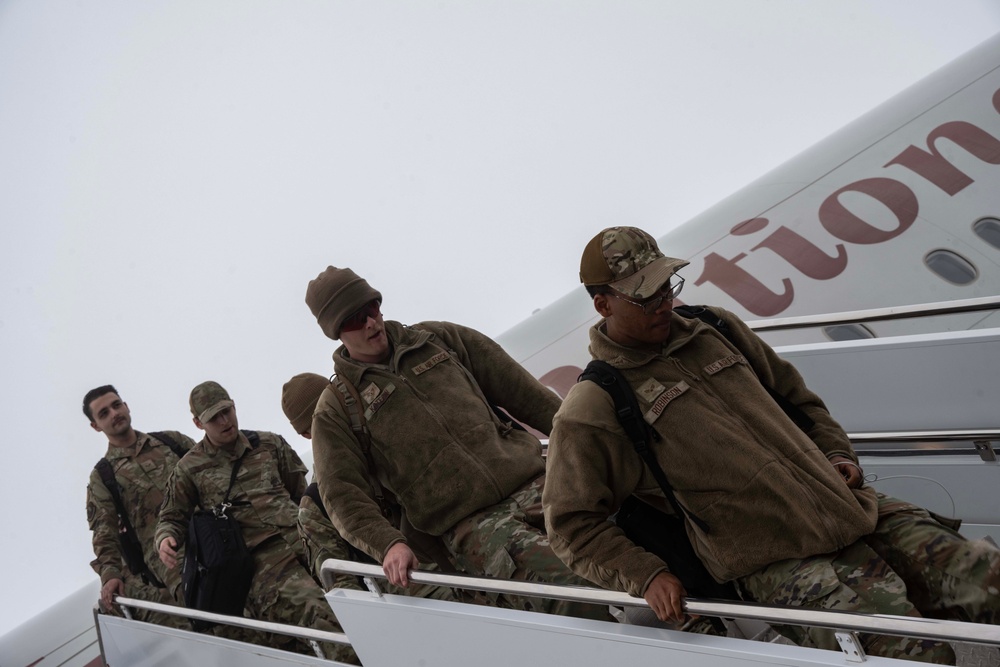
[579,359,710,533]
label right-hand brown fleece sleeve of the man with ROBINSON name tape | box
[710,308,858,463]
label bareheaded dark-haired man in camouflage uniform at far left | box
[83,385,194,628]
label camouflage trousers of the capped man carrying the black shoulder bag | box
[246,539,360,665]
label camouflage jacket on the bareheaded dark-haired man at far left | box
[87,431,194,589]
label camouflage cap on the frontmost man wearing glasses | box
[580,227,689,299]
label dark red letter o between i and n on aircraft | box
[819,178,920,245]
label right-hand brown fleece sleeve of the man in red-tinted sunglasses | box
[422,322,561,434]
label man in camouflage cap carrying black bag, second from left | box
[155,381,357,664]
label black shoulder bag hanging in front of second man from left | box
[182,431,260,630]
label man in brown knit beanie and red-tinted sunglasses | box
[306,266,611,620]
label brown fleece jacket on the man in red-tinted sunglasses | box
[312,321,559,562]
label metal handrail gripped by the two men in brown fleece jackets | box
[322,558,1000,646]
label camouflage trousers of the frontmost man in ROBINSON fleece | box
[739,494,1000,664]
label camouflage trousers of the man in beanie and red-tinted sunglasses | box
[441,475,614,621]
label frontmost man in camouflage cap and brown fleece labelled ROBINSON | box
[543,227,1000,664]
